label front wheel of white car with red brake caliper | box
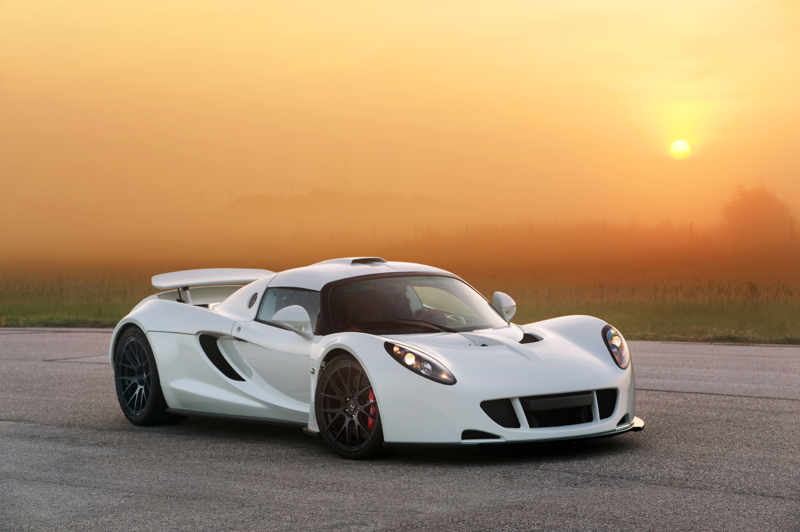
[314,355,383,460]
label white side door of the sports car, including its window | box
[234,288,319,405]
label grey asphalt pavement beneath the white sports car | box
[0,329,800,531]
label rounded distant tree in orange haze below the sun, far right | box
[722,184,793,248]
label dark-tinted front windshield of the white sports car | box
[329,276,506,334]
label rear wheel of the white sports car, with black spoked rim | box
[114,327,186,426]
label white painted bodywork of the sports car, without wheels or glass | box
[109,258,635,445]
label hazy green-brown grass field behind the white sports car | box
[0,266,800,344]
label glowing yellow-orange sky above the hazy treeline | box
[0,0,800,260]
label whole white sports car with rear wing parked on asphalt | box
[109,257,644,458]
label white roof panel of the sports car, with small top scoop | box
[269,257,453,290]
